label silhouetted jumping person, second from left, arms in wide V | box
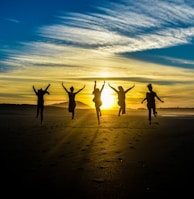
[62,82,85,120]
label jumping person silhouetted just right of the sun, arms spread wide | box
[108,84,135,116]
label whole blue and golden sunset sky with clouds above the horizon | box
[0,0,194,108]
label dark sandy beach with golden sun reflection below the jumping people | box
[0,105,194,199]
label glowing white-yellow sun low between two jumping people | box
[101,89,115,109]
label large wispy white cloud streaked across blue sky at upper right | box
[36,0,194,53]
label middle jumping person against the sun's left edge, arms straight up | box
[92,81,105,124]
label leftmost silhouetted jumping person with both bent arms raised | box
[32,84,50,124]
